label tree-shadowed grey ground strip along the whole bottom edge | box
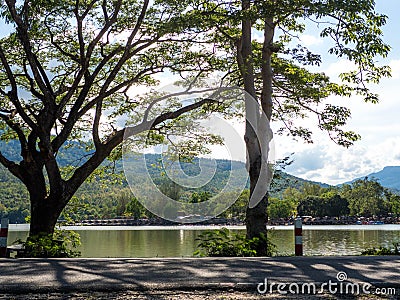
[0,256,400,300]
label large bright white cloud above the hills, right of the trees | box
[275,47,400,184]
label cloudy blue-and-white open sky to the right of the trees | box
[275,0,400,184]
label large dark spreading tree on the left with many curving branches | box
[0,0,222,235]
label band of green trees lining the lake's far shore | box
[64,178,400,220]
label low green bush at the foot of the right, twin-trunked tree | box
[194,228,276,257]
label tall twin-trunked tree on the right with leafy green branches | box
[194,0,390,254]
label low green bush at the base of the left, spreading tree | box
[14,229,81,258]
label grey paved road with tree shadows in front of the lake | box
[0,256,400,293]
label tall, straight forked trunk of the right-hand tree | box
[238,0,274,256]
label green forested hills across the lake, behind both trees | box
[0,138,400,223]
